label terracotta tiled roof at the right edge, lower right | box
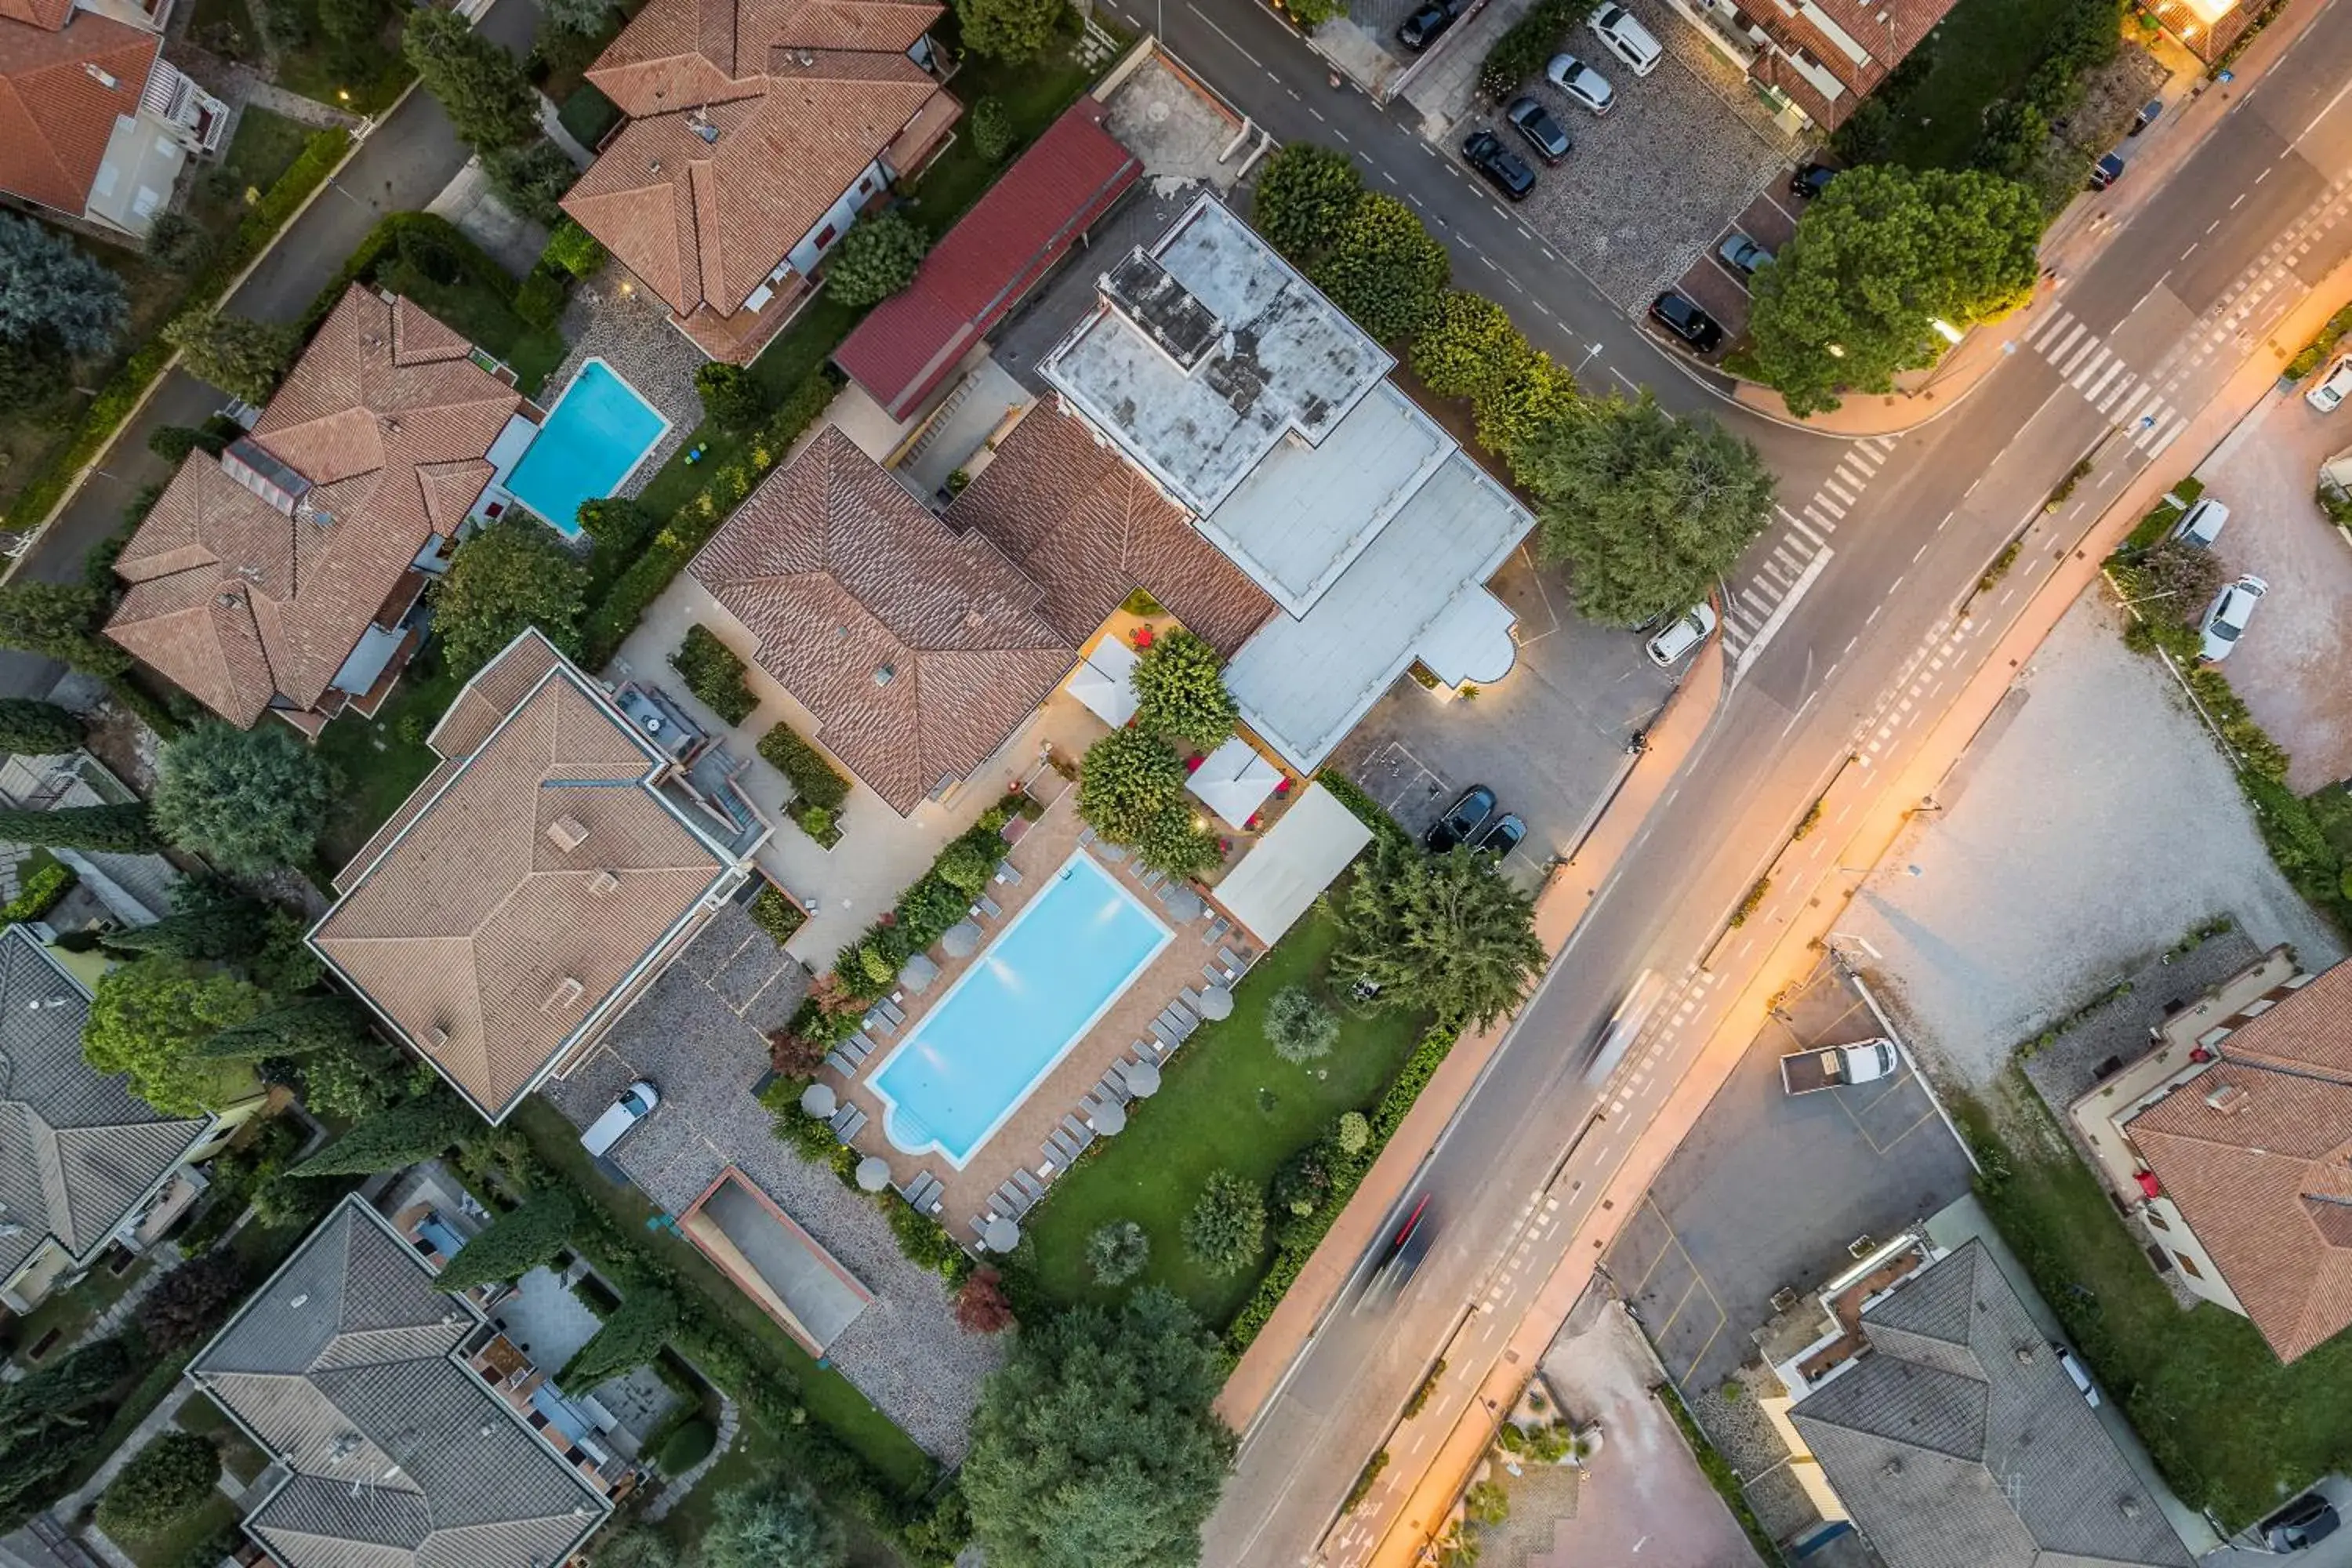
[2126,982,2352,1361]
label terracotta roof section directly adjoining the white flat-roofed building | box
[948,400,1275,659]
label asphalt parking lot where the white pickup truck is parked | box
[1604,959,1971,1392]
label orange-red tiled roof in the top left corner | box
[0,0,162,216]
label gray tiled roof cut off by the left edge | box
[0,926,212,1281]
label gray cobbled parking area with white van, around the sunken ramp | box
[546,905,1004,1465]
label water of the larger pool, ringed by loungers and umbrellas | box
[873,848,1174,1171]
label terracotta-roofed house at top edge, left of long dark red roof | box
[562,0,964,365]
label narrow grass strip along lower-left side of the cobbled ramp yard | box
[510,1098,934,1493]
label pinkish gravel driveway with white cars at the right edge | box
[2197,381,2352,794]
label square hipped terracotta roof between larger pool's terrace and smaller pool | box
[691,426,1077,813]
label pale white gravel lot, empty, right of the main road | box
[1846,587,2343,1083]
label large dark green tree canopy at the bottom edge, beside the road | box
[962,1290,1235,1568]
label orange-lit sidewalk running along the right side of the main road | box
[1371,208,2352,1568]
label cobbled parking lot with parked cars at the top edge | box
[1446,0,1797,320]
